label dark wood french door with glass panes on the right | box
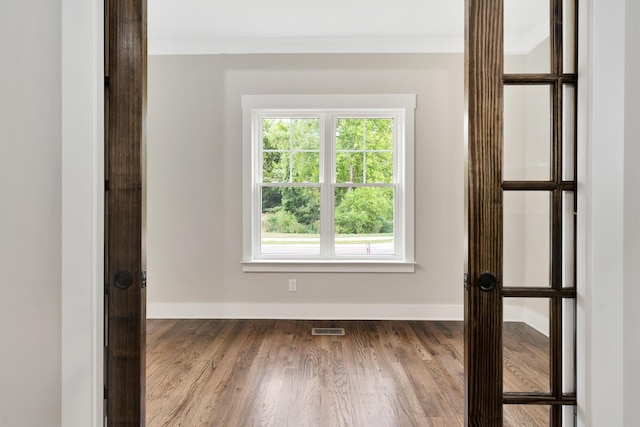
[465,0,577,426]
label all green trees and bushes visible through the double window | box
[262,118,394,234]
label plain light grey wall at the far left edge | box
[0,0,61,427]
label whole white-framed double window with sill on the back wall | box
[242,95,415,272]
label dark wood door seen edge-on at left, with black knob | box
[105,0,147,426]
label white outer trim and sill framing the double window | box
[242,94,416,273]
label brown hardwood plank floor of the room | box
[147,320,549,427]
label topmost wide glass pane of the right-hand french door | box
[504,0,551,74]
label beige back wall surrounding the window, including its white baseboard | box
[148,54,463,318]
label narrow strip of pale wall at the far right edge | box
[623,0,640,427]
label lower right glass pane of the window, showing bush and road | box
[335,187,395,255]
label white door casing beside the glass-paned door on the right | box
[577,0,628,426]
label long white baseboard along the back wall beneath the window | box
[147,303,463,320]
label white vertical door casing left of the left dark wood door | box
[62,0,104,427]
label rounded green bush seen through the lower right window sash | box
[335,187,393,234]
